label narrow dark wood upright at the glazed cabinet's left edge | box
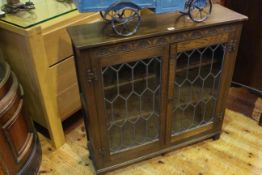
[73,46,104,167]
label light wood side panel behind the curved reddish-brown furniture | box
[0,29,46,127]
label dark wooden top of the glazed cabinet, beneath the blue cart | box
[68,4,247,49]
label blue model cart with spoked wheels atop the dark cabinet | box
[74,0,212,36]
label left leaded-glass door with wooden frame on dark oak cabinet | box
[92,46,169,166]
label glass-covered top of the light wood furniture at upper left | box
[0,0,76,28]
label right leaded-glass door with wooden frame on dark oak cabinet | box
[167,34,232,143]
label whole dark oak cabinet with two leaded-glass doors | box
[68,5,247,173]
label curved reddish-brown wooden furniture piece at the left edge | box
[0,62,41,175]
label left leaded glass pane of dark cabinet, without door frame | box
[101,57,162,154]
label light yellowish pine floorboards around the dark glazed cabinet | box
[40,110,262,175]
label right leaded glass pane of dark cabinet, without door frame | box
[172,44,225,135]
